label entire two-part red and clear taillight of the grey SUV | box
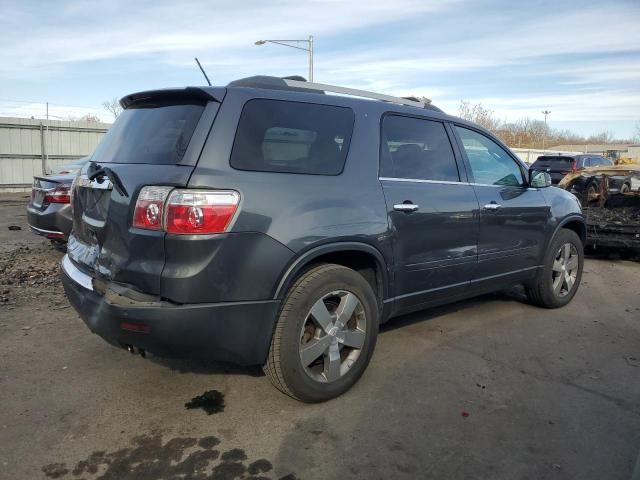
[133,187,240,235]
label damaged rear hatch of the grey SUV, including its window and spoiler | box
[67,88,224,294]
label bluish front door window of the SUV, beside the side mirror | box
[456,126,524,186]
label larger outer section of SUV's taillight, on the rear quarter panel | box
[165,190,240,235]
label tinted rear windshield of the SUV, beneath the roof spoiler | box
[91,104,204,164]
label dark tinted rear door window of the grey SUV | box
[380,115,460,182]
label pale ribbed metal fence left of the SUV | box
[0,117,111,192]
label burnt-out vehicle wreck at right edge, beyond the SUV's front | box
[558,163,640,249]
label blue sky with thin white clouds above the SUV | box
[0,0,640,137]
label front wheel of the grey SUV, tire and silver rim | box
[527,229,584,308]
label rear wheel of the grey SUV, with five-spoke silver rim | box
[263,264,378,403]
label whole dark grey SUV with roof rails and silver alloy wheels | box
[62,77,585,402]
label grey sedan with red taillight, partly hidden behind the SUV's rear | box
[27,175,75,245]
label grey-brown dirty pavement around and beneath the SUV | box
[0,195,640,480]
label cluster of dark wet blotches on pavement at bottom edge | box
[42,434,297,480]
